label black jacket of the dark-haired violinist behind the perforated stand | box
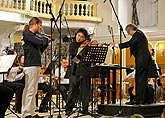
[69,42,91,77]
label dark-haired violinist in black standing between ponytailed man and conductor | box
[66,28,91,115]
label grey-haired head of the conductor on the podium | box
[125,24,137,36]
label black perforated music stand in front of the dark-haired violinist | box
[75,46,108,118]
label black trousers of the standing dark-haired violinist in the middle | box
[66,75,91,111]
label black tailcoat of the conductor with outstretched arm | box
[119,30,155,77]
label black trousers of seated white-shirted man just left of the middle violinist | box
[59,84,69,103]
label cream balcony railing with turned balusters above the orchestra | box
[0,0,102,22]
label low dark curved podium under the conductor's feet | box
[98,103,165,117]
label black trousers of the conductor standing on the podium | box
[135,65,148,103]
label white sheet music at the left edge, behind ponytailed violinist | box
[0,55,17,73]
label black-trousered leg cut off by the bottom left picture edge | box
[0,84,14,118]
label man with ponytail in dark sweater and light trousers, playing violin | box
[22,17,51,118]
